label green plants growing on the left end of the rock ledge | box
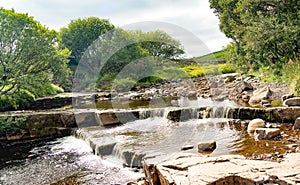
[0,116,27,136]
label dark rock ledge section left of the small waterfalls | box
[0,109,152,141]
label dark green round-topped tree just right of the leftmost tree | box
[60,17,115,70]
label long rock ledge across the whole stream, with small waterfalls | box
[0,107,300,140]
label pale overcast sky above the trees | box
[0,0,229,55]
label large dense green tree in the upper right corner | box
[210,0,300,69]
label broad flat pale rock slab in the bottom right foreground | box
[144,153,300,185]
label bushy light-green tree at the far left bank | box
[0,8,70,106]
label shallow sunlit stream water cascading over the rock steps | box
[0,98,298,184]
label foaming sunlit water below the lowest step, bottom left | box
[0,136,142,185]
